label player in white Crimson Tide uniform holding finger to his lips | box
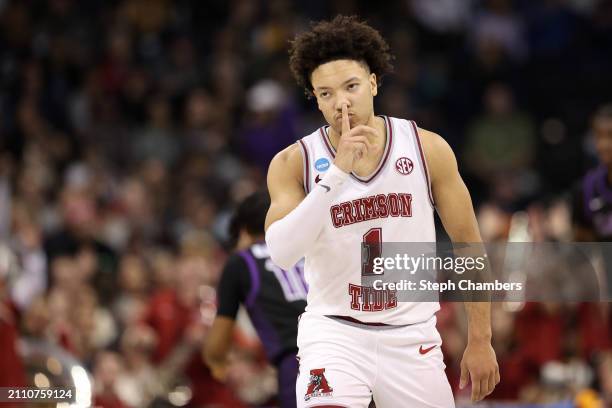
[266,16,499,408]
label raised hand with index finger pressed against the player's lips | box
[334,104,376,173]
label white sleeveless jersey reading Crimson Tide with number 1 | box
[298,117,439,325]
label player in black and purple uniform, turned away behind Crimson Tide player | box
[204,191,307,408]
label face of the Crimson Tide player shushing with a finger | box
[311,60,378,133]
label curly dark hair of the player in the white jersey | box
[289,15,394,96]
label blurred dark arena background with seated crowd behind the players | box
[0,0,612,407]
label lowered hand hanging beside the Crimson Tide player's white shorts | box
[459,340,500,402]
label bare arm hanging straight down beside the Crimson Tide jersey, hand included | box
[419,129,500,401]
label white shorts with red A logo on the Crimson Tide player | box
[296,313,455,408]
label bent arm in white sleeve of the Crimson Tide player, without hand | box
[265,145,348,269]
